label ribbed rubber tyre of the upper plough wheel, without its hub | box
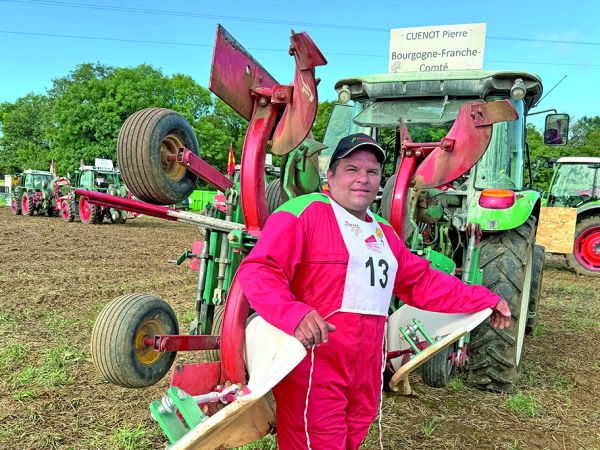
[117,108,199,205]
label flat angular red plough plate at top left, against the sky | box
[208,24,278,120]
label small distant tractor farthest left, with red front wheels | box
[10,169,56,217]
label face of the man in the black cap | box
[327,149,381,220]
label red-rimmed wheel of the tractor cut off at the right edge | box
[566,216,600,277]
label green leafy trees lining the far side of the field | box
[0,63,600,189]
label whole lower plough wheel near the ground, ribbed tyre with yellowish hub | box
[91,294,179,388]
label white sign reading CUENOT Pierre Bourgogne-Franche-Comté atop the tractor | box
[388,23,486,72]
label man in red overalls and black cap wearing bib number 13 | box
[237,134,510,450]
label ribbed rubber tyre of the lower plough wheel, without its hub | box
[91,294,179,388]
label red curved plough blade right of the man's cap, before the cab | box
[411,100,519,189]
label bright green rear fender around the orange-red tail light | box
[467,191,540,231]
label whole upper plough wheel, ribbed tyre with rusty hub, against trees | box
[117,108,200,205]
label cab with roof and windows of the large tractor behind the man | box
[320,70,552,195]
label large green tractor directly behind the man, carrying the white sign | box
[319,70,560,392]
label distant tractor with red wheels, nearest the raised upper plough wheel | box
[57,158,127,224]
